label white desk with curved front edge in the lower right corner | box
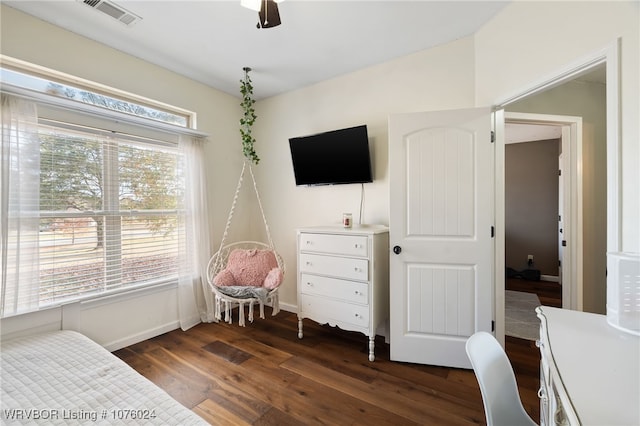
[536,306,640,426]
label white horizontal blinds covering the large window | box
[34,120,185,307]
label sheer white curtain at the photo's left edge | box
[0,94,40,317]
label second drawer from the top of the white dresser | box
[300,253,369,281]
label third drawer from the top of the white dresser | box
[300,274,369,305]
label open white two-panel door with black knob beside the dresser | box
[389,108,495,368]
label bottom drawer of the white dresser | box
[300,294,369,328]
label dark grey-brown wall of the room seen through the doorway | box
[505,139,560,277]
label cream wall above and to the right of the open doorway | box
[475,1,640,253]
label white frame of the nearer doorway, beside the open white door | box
[493,38,622,345]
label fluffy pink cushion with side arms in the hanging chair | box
[213,249,282,289]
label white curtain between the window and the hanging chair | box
[178,136,215,330]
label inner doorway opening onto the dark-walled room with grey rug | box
[504,119,575,340]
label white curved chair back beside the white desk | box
[466,331,536,426]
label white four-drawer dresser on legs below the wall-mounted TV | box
[297,225,389,361]
